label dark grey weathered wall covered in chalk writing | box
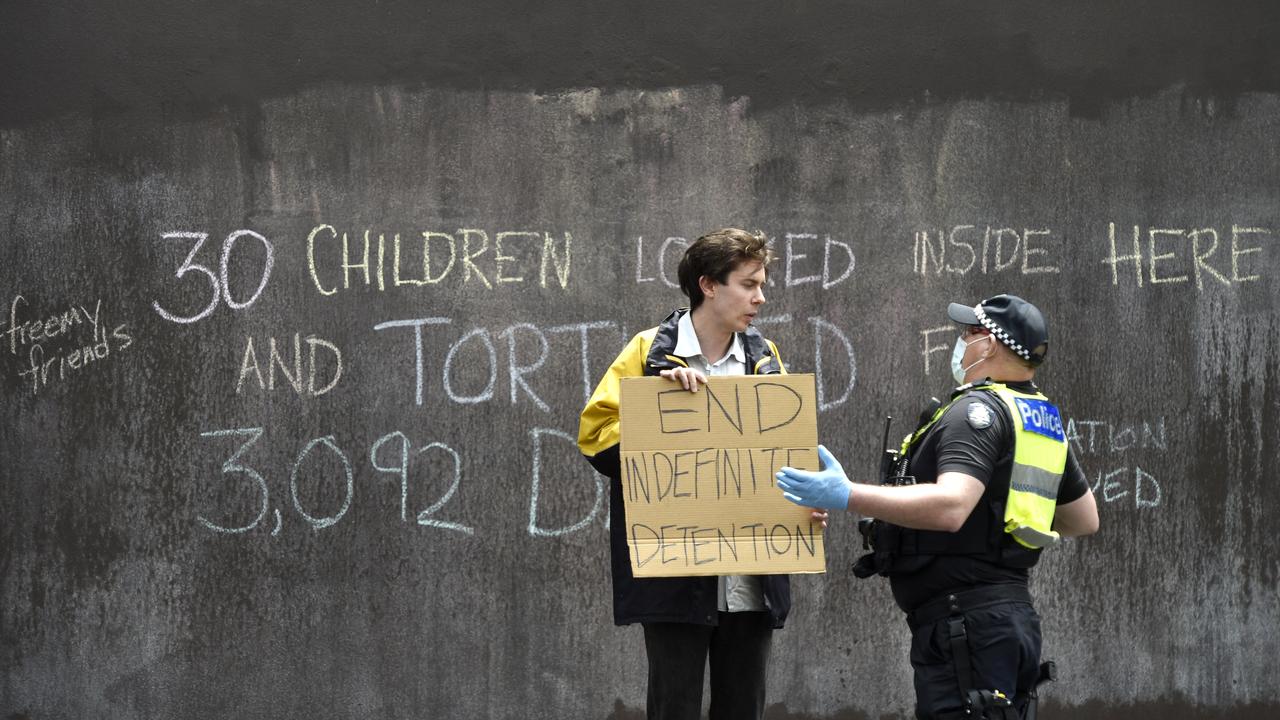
[0,3,1280,719]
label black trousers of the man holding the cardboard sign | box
[644,612,773,720]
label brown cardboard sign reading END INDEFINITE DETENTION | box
[620,374,827,578]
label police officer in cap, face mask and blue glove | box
[778,295,1098,719]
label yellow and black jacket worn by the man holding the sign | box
[577,307,791,628]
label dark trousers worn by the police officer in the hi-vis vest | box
[911,601,1041,720]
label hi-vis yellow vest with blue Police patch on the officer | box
[901,382,1066,550]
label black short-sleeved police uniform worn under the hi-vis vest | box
[858,382,1089,719]
